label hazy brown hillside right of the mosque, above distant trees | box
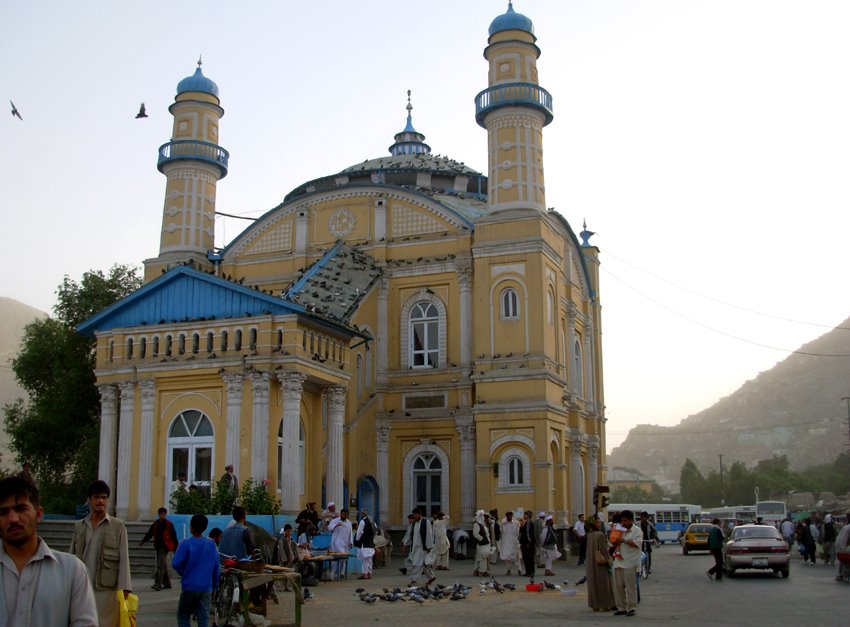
[608,319,850,493]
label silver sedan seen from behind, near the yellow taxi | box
[723,525,791,579]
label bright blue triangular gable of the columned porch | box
[77,266,322,335]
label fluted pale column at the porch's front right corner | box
[277,372,307,515]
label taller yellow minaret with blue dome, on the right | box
[475,2,552,213]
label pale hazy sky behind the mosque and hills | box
[0,0,850,449]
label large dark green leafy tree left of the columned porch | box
[4,265,142,512]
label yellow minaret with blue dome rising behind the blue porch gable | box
[145,59,230,280]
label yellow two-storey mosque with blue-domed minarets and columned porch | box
[79,4,606,526]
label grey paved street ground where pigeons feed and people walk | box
[134,545,850,627]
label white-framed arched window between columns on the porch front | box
[166,409,215,496]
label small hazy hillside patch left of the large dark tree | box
[0,297,47,470]
